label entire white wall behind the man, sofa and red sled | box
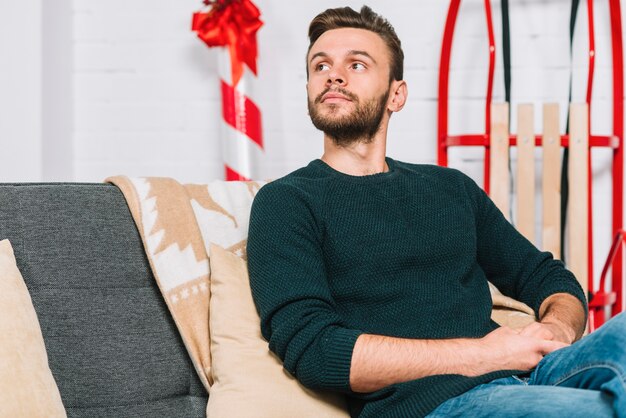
[0,0,612,284]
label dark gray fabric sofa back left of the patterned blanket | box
[0,183,207,418]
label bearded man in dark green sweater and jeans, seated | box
[248,7,626,417]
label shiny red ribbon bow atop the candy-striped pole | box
[191,0,263,86]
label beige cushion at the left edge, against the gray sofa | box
[0,239,66,418]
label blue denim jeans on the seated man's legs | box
[428,313,626,418]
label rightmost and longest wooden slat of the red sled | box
[567,103,589,294]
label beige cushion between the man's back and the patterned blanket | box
[207,244,349,418]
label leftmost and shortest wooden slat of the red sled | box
[489,103,511,219]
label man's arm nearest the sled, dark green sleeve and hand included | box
[466,174,587,330]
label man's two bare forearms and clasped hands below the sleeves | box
[350,293,585,392]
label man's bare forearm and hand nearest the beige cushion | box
[350,327,567,392]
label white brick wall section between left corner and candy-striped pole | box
[74,0,222,182]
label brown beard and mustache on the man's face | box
[308,88,390,147]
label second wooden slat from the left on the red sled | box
[516,104,535,242]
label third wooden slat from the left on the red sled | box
[542,103,561,258]
